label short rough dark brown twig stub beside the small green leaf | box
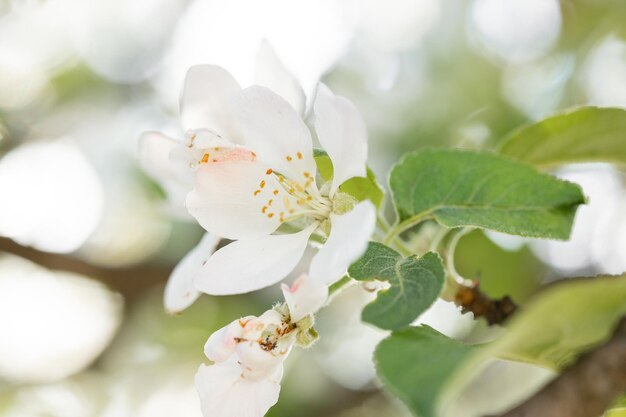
[454,281,517,325]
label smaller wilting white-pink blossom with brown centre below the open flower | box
[196,275,328,417]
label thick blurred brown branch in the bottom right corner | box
[492,317,626,417]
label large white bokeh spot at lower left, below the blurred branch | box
[0,252,122,382]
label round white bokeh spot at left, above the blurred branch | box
[0,140,104,253]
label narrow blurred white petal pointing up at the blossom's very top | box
[255,40,306,116]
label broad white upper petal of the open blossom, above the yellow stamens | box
[235,86,316,181]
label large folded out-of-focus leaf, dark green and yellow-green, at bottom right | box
[375,275,626,417]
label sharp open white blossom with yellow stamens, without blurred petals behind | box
[187,78,376,295]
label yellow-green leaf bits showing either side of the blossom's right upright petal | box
[313,149,385,207]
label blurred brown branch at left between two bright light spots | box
[0,238,173,302]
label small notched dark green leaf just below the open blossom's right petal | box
[348,242,444,330]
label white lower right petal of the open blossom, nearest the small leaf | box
[309,200,376,284]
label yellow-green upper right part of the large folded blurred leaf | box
[480,275,626,370]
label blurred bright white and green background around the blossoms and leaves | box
[0,0,626,417]
